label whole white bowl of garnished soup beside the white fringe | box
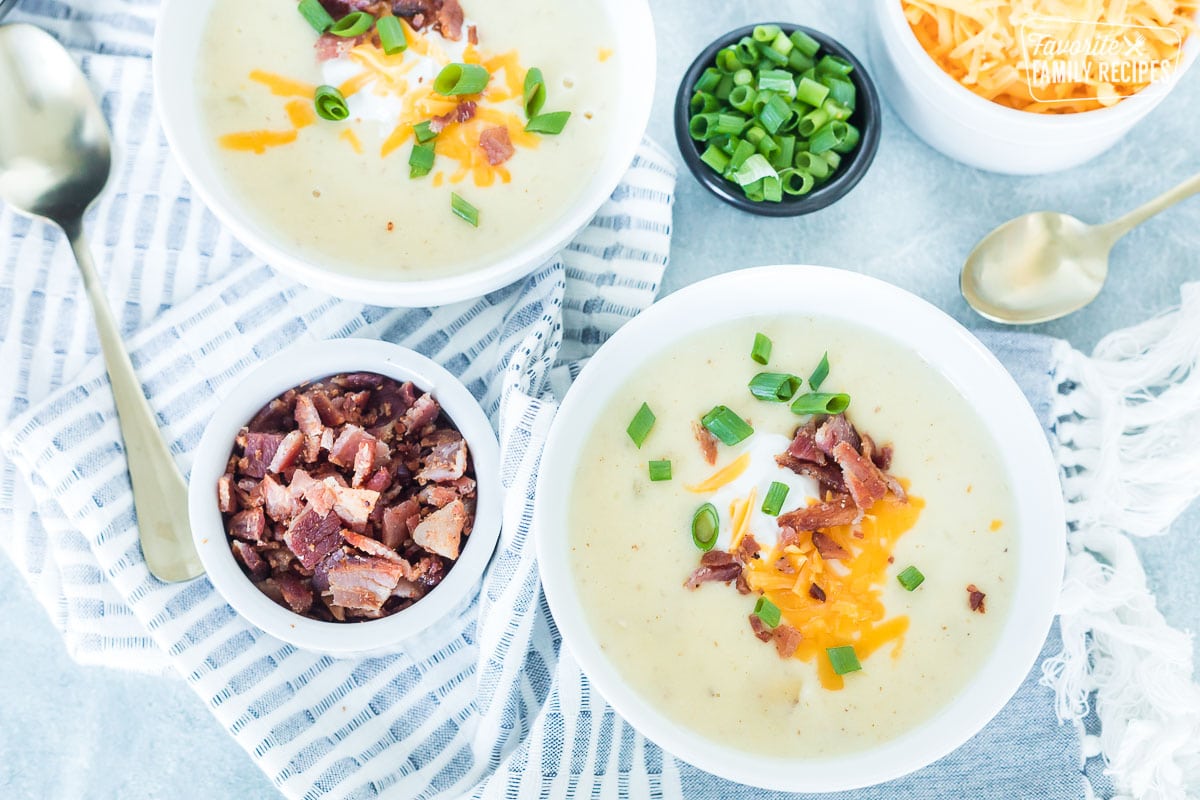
[534,266,1066,792]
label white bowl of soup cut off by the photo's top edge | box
[154,0,655,306]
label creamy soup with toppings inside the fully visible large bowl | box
[569,318,1016,758]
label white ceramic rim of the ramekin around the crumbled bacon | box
[187,338,503,655]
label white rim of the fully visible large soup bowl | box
[534,266,1066,792]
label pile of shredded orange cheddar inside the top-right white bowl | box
[901,0,1198,114]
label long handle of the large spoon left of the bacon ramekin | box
[64,219,204,582]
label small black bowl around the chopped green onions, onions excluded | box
[676,23,882,217]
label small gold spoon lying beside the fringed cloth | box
[960,175,1200,325]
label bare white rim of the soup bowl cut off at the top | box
[152,0,656,307]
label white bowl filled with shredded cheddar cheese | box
[871,0,1200,175]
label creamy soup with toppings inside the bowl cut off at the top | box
[197,0,620,279]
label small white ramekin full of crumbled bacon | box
[188,338,503,655]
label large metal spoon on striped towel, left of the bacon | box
[0,25,202,581]
